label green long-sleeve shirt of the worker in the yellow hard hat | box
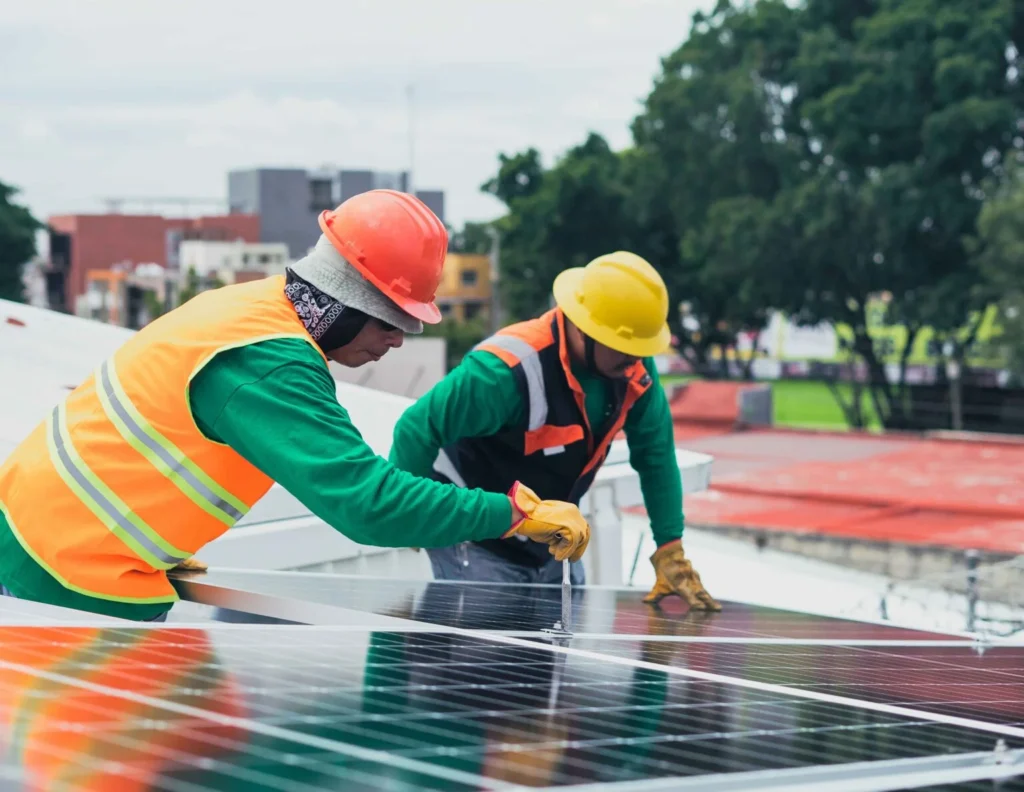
[390,350,683,545]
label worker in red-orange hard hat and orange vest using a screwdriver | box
[0,191,590,621]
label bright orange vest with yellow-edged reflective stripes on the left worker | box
[0,276,327,605]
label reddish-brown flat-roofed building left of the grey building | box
[45,214,260,314]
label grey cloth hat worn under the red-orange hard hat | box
[292,234,423,334]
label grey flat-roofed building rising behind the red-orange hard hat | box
[227,168,444,259]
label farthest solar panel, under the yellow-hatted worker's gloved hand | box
[167,570,966,641]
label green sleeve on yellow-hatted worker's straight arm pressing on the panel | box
[625,358,683,547]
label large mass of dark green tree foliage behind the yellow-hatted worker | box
[484,0,1024,427]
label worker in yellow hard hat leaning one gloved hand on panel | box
[390,251,720,611]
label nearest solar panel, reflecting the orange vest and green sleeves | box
[0,626,1024,790]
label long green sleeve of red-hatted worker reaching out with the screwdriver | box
[189,339,512,547]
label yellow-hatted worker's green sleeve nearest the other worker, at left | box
[390,350,525,475]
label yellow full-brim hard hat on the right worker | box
[554,250,672,358]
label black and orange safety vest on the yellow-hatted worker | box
[432,308,652,566]
